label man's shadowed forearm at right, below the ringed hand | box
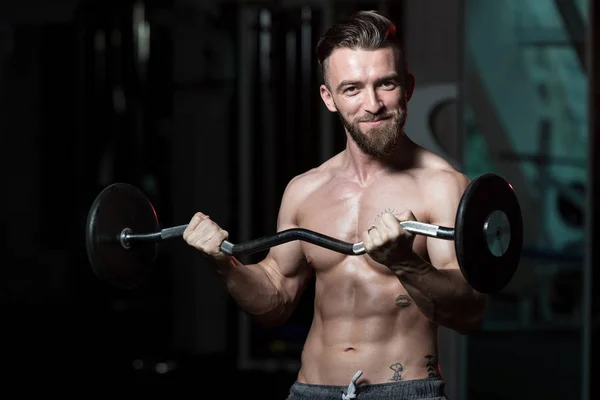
[392,256,485,333]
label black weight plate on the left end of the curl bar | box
[86,183,159,289]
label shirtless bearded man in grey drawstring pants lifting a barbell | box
[183,12,485,399]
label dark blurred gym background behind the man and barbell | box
[0,0,600,400]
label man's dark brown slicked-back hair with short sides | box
[316,11,407,85]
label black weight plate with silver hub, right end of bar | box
[454,174,523,293]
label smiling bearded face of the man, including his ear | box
[321,47,413,157]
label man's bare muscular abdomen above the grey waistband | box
[298,259,438,385]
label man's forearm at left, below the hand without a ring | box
[215,257,288,325]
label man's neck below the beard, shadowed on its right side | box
[344,134,416,185]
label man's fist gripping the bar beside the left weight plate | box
[183,212,229,261]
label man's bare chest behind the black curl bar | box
[298,179,428,271]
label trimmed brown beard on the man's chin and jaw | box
[338,109,406,158]
